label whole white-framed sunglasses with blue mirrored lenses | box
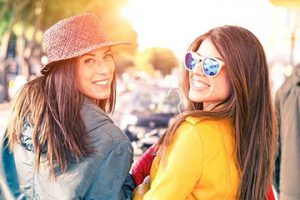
[184,51,225,78]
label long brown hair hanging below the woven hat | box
[8,58,116,177]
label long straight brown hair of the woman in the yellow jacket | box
[159,26,277,200]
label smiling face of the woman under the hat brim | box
[76,47,115,100]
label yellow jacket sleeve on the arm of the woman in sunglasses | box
[144,122,203,200]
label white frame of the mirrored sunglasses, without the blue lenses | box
[184,51,225,78]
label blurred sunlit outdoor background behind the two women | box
[0,0,300,154]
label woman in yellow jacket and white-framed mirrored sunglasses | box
[133,26,277,200]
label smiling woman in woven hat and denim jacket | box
[1,13,134,200]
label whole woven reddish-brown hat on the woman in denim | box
[41,13,130,75]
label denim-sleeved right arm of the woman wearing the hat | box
[86,140,135,200]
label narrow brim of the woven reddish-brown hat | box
[41,41,132,75]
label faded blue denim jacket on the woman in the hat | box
[1,99,135,200]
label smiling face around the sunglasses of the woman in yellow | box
[188,39,231,110]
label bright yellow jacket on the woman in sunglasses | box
[143,117,239,200]
